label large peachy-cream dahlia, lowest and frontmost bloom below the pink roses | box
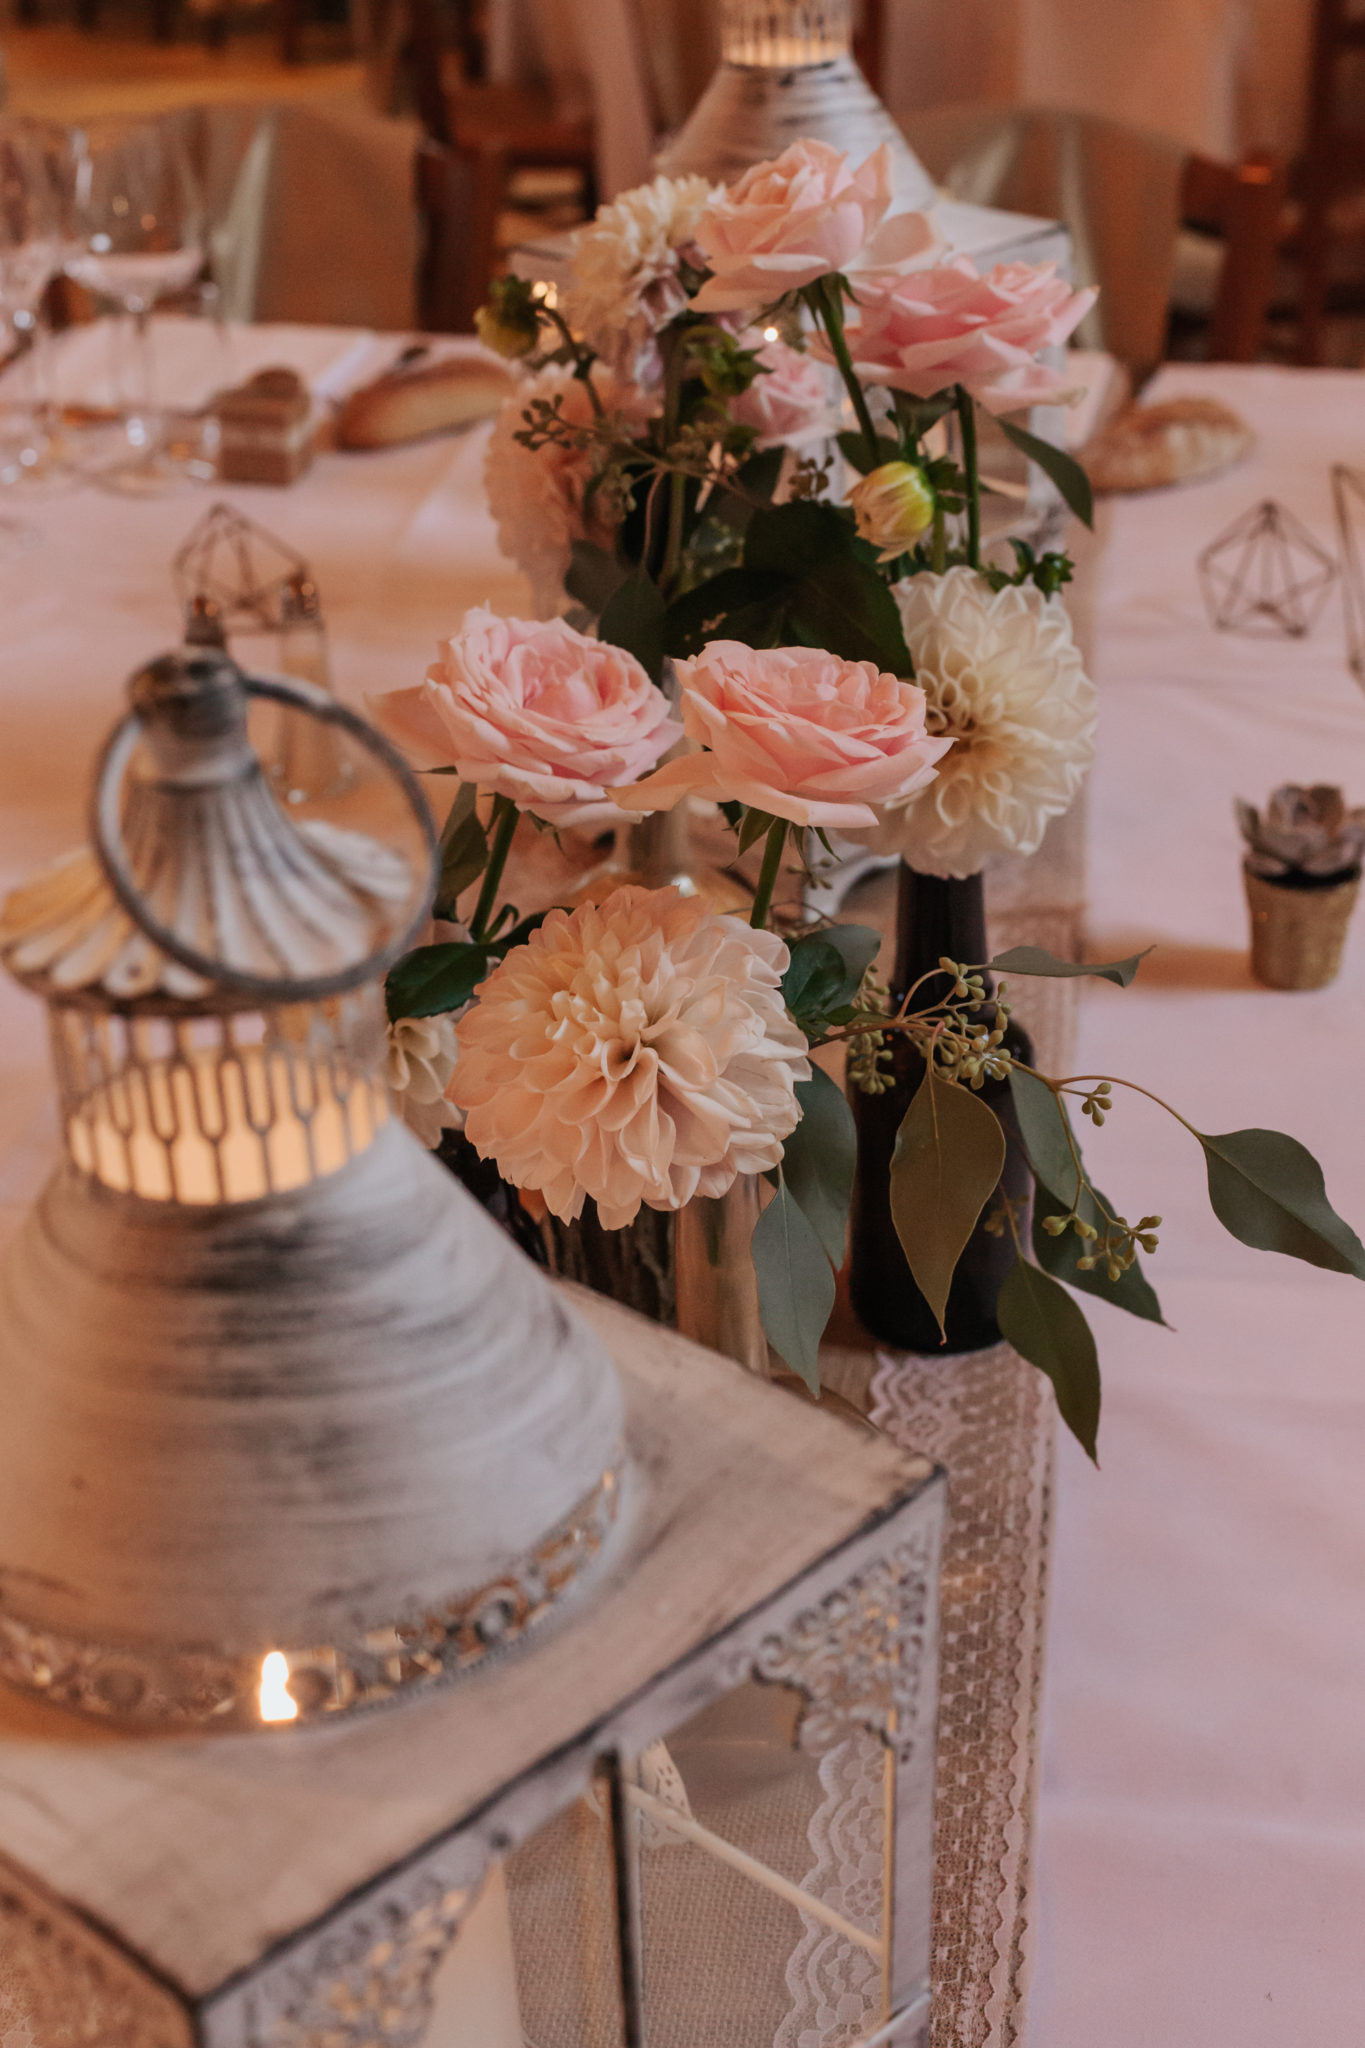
[452,889,810,1231]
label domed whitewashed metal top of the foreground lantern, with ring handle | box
[0,647,622,1726]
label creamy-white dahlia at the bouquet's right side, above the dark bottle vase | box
[874,567,1095,877]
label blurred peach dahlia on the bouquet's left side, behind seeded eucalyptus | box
[483,362,651,618]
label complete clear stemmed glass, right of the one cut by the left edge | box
[65,121,205,492]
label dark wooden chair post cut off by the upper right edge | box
[1289,0,1365,362]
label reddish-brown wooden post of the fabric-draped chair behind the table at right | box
[1181,154,1287,362]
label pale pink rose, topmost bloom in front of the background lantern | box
[692,141,937,313]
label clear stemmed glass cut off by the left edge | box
[0,119,61,536]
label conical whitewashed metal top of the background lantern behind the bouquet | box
[659,0,935,209]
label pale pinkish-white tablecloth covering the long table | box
[0,330,1365,2048]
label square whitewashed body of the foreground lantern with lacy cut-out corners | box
[0,1290,943,2048]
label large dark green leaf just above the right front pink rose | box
[745,500,915,676]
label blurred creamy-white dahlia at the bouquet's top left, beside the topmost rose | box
[563,176,720,383]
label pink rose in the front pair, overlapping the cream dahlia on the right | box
[612,641,950,825]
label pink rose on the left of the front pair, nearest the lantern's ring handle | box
[370,606,681,825]
